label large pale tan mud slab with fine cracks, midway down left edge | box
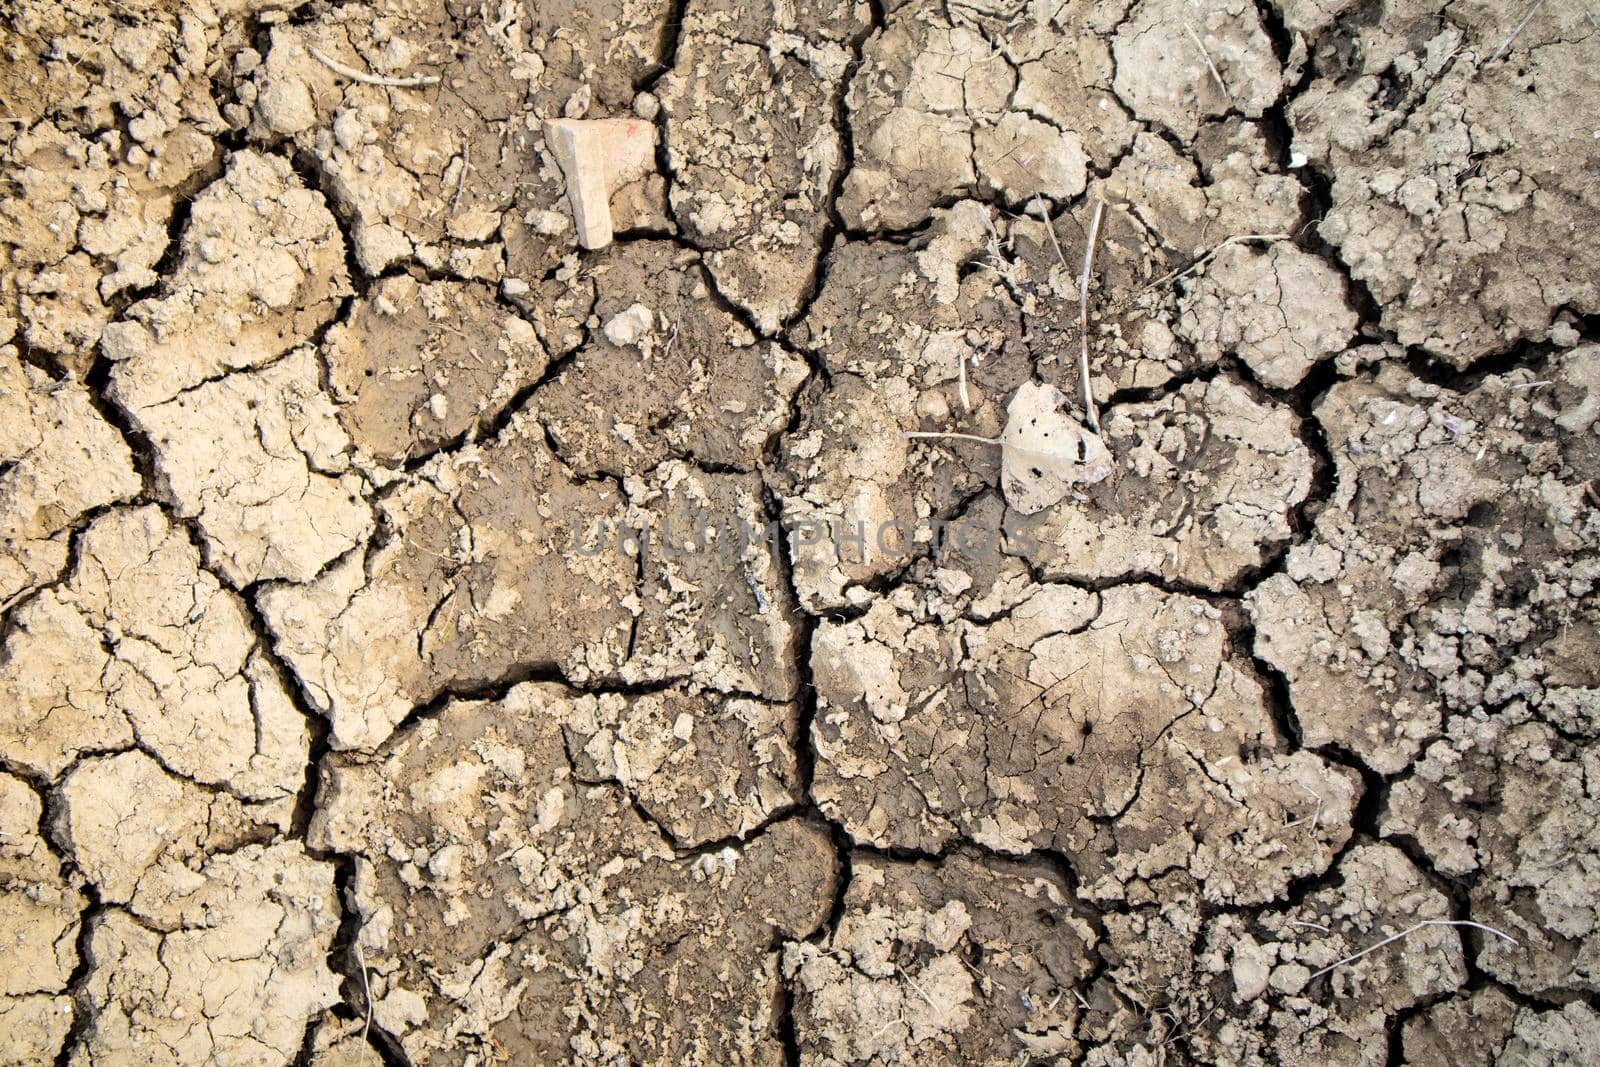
[0,506,309,796]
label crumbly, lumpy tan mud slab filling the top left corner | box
[0,3,236,374]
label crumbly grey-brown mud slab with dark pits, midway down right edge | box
[1248,346,1600,774]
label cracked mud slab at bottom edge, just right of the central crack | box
[784,854,1096,1064]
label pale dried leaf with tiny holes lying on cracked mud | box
[1000,382,1112,515]
